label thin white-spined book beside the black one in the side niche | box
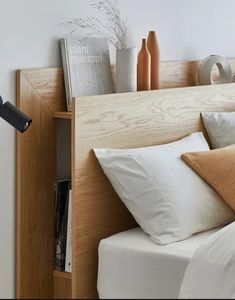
[65,189,72,272]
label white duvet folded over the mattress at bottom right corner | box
[178,222,235,299]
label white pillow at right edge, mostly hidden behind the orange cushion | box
[201,112,235,149]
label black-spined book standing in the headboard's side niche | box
[54,179,71,271]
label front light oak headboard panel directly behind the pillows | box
[72,83,235,298]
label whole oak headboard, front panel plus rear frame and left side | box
[16,62,235,299]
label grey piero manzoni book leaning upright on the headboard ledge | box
[60,37,113,111]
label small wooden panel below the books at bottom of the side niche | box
[54,271,72,299]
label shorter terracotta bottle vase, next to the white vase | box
[137,39,151,91]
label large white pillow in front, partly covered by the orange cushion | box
[94,132,235,245]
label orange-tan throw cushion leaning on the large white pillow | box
[181,145,235,211]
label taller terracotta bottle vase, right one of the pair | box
[147,31,160,90]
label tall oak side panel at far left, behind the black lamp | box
[16,69,65,299]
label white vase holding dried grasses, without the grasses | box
[116,47,137,93]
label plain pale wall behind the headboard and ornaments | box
[0,0,235,298]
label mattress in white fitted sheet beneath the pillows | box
[97,228,220,299]
